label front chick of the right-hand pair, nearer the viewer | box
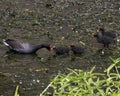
[94,33,113,47]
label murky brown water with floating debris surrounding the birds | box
[0,0,120,96]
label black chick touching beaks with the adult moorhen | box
[51,46,70,55]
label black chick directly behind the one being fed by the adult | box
[70,44,85,54]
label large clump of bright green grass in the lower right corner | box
[40,58,120,96]
